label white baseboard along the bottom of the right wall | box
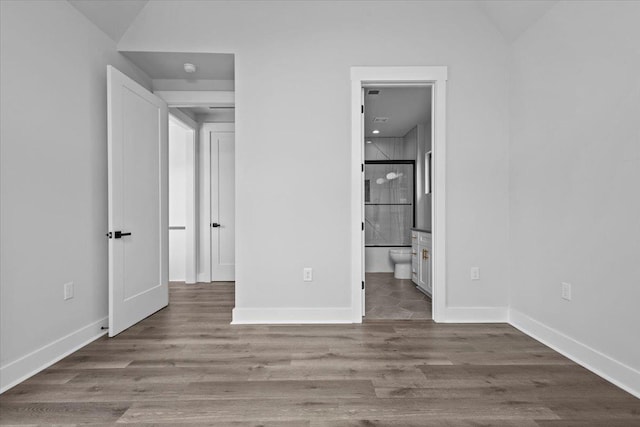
[509,309,640,399]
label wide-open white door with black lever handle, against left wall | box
[107,66,169,336]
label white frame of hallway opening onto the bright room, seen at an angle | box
[169,106,198,284]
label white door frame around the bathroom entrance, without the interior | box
[350,66,447,323]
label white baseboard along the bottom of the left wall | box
[0,317,109,394]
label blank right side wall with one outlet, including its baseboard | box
[509,2,640,396]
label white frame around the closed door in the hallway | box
[198,122,237,283]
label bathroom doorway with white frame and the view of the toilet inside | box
[351,67,447,321]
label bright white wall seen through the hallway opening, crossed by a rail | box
[169,119,190,282]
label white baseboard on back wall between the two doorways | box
[231,307,353,325]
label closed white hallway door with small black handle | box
[208,123,236,282]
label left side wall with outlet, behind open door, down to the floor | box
[0,1,150,389]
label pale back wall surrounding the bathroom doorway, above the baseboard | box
[119,1,508,320]
